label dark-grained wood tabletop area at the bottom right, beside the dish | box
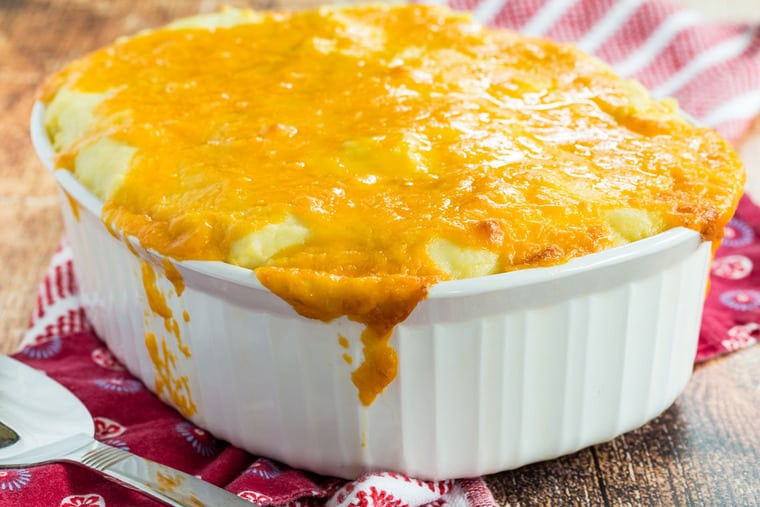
[487,348,760,506]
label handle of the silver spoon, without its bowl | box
[66,440,251,507]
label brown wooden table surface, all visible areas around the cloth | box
[0,0,760,505]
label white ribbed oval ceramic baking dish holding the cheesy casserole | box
[31,104,710,479]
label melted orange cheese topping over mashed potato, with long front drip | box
[41,5,744,403]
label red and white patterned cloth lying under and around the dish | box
[0,0,760,507]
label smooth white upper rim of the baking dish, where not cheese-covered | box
[29,100,704,300]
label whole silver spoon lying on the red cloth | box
[0,356,251,507]
